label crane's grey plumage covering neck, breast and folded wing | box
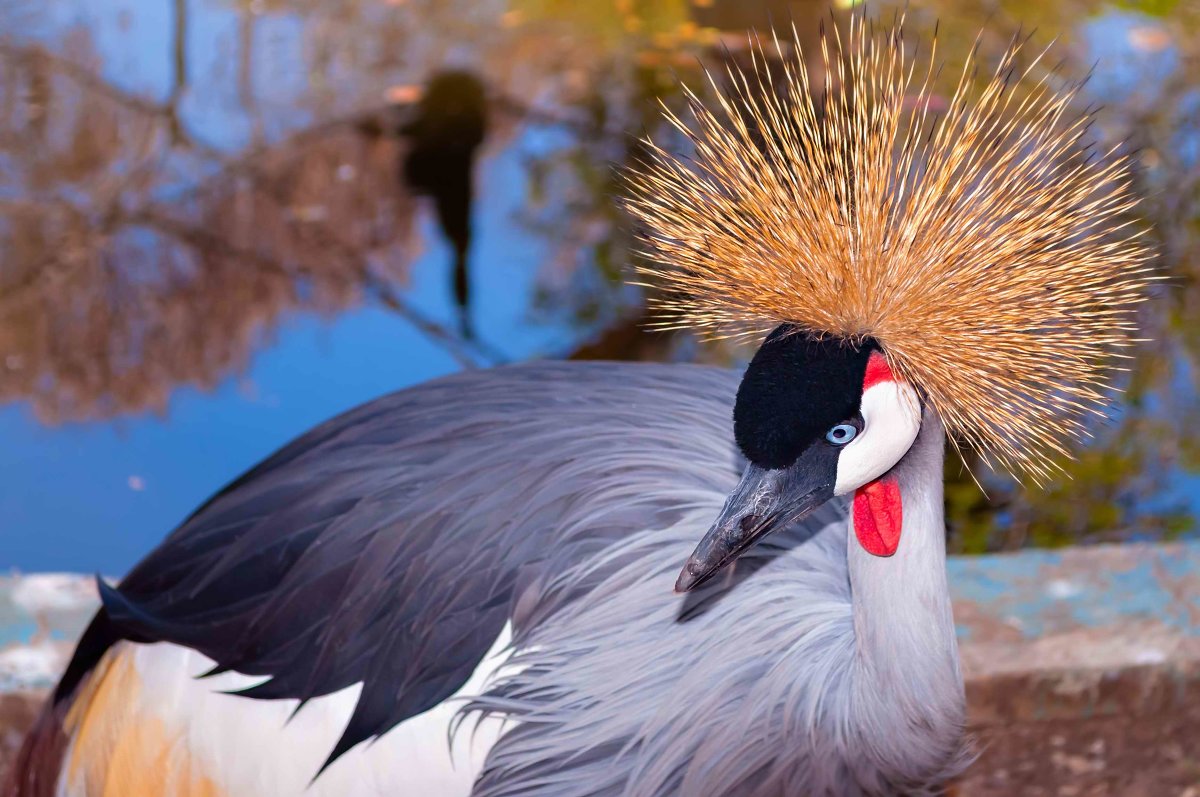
[63,364,962,797]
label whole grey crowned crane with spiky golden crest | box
[5,18,1152,797]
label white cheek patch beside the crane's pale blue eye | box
[833,380,920,496]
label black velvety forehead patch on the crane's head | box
[733,324,878,468]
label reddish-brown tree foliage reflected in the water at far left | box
[0,31,422,420]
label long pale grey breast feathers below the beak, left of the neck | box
[469,499,854,797]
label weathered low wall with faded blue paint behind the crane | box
[0,543,1200,797]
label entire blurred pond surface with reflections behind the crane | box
[0,0,1200,575]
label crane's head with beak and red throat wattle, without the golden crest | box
[676,324,922,592]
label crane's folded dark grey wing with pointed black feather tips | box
[42,362,737,765]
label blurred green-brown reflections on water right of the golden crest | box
[918,2,1200,552]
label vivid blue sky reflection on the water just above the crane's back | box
[0,130,581,574]
